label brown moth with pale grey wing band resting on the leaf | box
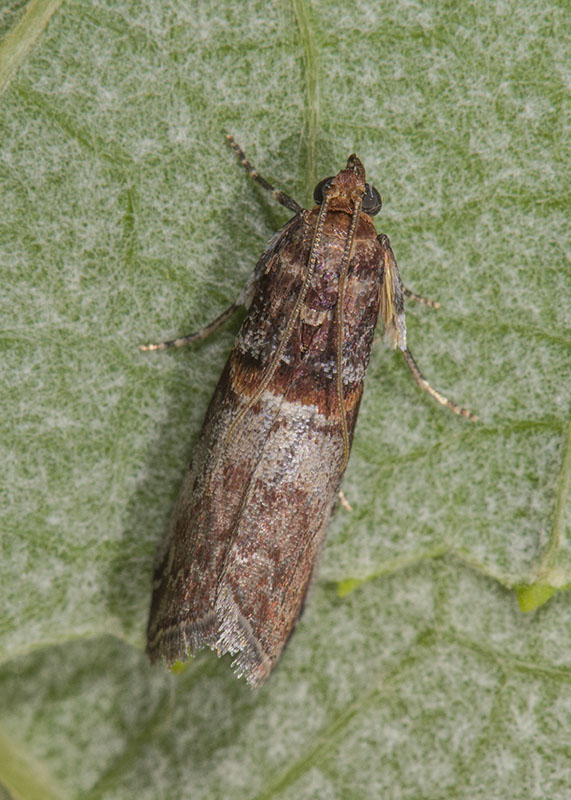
[142,136,474,686]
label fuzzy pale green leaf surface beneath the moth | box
[0,0,571,800]
